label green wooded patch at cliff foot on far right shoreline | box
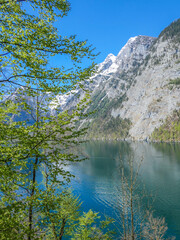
[151,110,180,142]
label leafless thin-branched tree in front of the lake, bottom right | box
[115,155,174,240]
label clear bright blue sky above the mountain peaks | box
[56,0,180,63]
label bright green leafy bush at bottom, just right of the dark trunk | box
[38,186,80,239]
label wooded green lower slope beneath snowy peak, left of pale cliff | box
[84,91,131,139]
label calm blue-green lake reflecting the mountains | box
[71,141,180,239]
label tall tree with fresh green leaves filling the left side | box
[0,0,98,240]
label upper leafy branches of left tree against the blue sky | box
[0,0,95,94]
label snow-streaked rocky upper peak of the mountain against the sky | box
[89,36,155,99]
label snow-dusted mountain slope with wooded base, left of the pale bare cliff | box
[82,36,155,138]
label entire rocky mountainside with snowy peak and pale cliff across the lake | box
[52,19,180,140]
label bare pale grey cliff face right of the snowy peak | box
[114,36,180,139]
